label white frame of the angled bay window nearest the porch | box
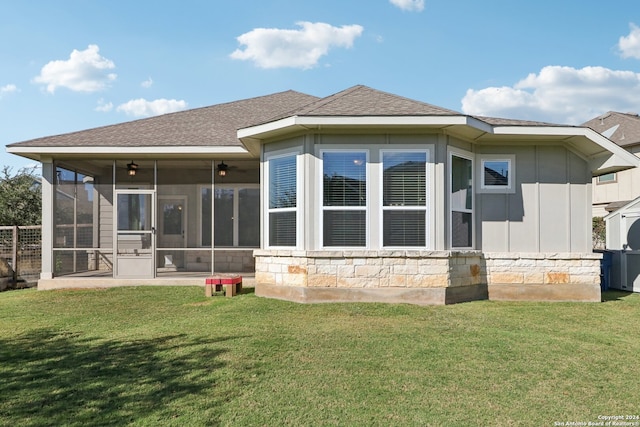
[262,147,306,249]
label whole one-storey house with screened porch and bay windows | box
[8,86,640,304]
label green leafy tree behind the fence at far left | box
[0,166,42,225]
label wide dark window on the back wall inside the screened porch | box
[201,185,260,247]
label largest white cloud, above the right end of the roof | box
[462,66,640,124]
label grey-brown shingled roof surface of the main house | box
[8,85,580,148]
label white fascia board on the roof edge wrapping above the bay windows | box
[238,115,472,139]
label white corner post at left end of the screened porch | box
[40,158,56,279]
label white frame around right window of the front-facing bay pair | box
[377,149,433,249]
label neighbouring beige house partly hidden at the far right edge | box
[582,111,640,217]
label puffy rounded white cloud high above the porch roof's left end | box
[33,44,116,93]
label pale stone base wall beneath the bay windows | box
[254,250,487,304]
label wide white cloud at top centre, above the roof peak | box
[231,22,363,69]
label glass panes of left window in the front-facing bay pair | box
[320,150,367,247]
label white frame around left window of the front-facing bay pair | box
[317,147,372,250]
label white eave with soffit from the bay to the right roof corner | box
[238,115,640,176]
